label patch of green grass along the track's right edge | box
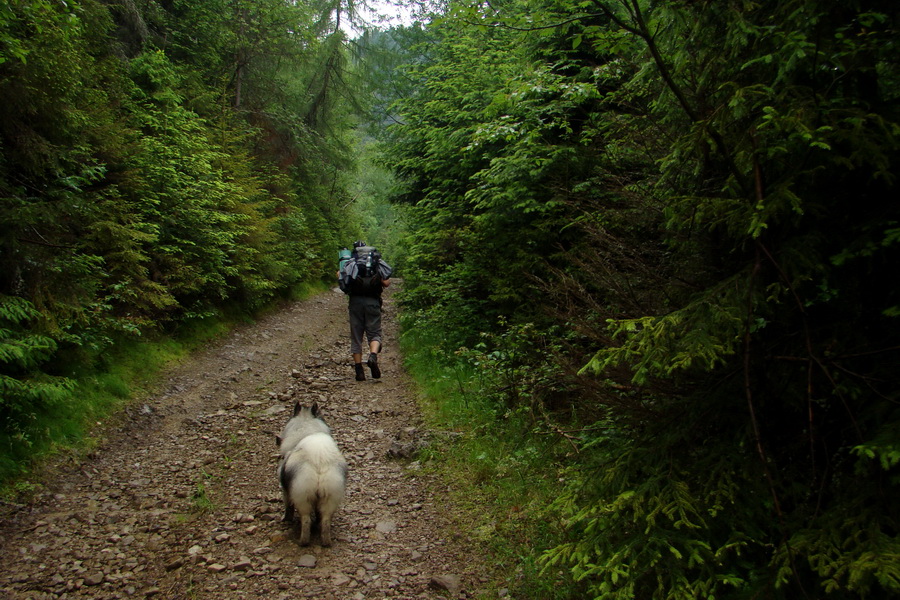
[401,331,577,599]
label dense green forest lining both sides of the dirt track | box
[0,0,900,599]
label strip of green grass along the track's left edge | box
[0,283,326,501]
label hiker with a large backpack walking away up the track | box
[338,241,393,381]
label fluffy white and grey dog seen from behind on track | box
[275,402,347,546]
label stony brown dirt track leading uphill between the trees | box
[0,292,486,600]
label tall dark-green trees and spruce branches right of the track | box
[392,0,900,598]
